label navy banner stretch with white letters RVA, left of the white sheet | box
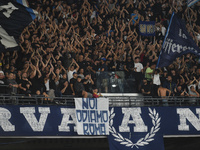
[0,106,77,136]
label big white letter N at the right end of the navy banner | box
[177,108,200,131]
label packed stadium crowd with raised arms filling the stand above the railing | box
[0,0,200,97]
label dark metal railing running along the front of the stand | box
[0,94,200,107]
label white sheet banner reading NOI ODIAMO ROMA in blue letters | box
[75,98,109,135]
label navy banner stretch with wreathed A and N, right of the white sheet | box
[108,107,200,150]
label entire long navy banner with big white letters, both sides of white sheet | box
[0,105,200,139]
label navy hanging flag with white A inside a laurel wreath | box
[108,107,164,150]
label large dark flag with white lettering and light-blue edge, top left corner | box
[0,0,37,52]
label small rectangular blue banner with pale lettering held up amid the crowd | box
[139,21,155,36]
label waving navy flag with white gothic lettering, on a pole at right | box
[157,13,200,68]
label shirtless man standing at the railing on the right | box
[158,86,171,106]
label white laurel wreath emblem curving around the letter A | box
[109,108,161,148]
